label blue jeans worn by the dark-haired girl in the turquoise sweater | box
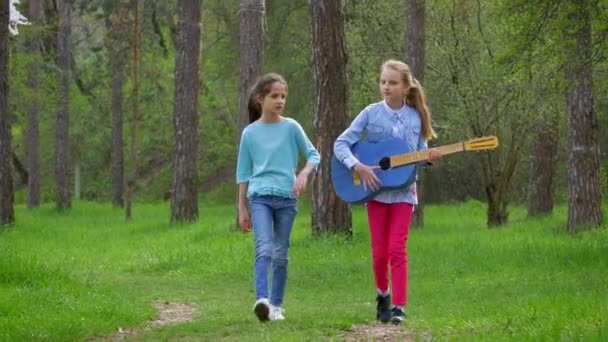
[249,195,298,306]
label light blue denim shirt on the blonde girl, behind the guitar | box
[334,101,427,204]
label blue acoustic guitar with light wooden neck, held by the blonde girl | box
[331,136,498,204]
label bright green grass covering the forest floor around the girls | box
[0,202,608,341]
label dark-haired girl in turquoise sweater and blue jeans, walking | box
[236,73,320,321]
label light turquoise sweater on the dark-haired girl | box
[236,118,320,198]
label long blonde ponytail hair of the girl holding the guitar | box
[380,59,437,141]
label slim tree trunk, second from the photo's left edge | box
[26,0,42,209]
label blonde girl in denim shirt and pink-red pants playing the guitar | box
[334,60,442,324]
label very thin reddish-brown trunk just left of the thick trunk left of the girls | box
[125,0,141,220]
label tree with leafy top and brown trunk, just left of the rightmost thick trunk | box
[500,0,563,216]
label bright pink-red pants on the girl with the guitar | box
[367,201,414,305]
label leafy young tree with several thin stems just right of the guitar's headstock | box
[427,0,538,227]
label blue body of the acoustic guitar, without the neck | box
[331,138,416,204]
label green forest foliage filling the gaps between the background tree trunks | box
[5,0,608,207]
